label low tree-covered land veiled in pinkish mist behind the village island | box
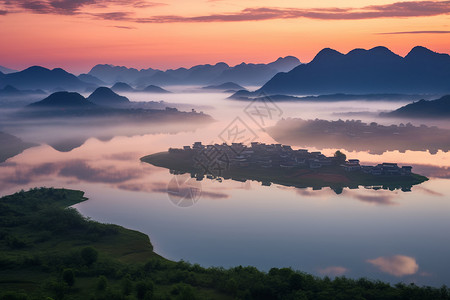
[266,118,450,154]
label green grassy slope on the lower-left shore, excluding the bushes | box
[0,189,232,299]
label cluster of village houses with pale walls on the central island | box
[169,142,412,176]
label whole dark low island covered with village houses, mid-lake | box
[141,142,428,194]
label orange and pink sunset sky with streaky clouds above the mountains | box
[0,0,450,73]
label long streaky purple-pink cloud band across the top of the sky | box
[0,0,450,23]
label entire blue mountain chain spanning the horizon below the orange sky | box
[0,46,450,96]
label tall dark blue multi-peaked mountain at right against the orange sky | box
[260,46,450,95]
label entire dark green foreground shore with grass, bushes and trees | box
[0,188,450,300]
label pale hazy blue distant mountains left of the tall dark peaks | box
[88,56,300,88]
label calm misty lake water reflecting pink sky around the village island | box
[0,87,450,286]
